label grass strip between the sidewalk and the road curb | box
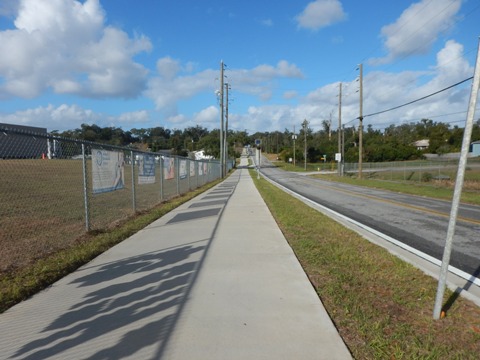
[250,171,480,359]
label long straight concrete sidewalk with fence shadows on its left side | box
[0,158,351,360]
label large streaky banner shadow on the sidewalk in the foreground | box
[15,243,206,360]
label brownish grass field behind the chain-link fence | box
[0,159,210,277]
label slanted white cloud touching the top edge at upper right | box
[370,0,462,64]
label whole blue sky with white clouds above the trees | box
[0,0,480,134]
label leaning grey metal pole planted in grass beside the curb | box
[433,39,480,320]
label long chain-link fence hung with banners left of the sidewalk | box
[0,126,233,273]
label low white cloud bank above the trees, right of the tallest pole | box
[232,40,473,133]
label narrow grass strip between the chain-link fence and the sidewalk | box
[0,180,222,313]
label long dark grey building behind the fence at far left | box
[0,123,48,159]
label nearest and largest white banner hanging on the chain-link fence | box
[92,149,125,194]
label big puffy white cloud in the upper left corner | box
[0,0,151,99]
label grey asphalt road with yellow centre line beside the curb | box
[261,159,480,277]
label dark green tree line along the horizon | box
[55,119,480,163]
